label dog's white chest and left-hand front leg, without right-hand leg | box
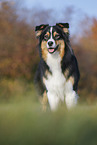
[45,52,66,109]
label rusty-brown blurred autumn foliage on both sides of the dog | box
[0,2,97,100]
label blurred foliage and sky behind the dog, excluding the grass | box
[0,0,97,103]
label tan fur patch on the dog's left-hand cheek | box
[41,41,48,61]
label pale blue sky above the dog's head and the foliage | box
[15,0,97,35]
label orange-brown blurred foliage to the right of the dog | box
[74,19,97,99]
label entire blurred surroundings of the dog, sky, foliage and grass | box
[0,0,97,145]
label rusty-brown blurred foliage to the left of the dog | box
[0,2,38,79]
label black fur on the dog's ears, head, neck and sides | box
[35,23,80,95]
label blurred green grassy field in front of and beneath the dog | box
[0,79,97,145]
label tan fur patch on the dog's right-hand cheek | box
[56,40,65,59]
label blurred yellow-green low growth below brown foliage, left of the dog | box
[0,78,37,102]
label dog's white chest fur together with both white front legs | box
[45,52,78,110]
